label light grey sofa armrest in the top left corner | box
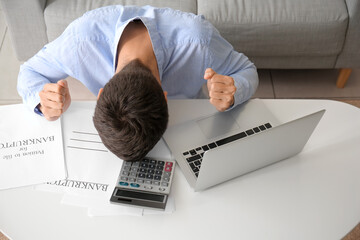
[0,0,48,61]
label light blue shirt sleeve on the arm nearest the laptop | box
[210,29,259,109]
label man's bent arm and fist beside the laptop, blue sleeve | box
[204,28,259,111]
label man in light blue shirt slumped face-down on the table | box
[18,6,258,161]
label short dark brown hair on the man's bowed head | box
[93,60,169,161]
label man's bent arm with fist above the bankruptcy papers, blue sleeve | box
[17,24,76,120]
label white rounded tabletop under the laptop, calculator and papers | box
[0,100,360,240]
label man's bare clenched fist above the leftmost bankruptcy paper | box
[39,80,71,121]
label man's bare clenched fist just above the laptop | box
[204,68,236,112]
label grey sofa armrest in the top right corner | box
[335,0,360,68]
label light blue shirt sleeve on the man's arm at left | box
[17,22,78,110]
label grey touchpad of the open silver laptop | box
[197,112,239,138]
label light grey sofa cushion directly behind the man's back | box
[44,0,196,41]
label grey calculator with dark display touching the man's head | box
[110,157,175,209]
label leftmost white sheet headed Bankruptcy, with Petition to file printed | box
[0,104,66,189]
